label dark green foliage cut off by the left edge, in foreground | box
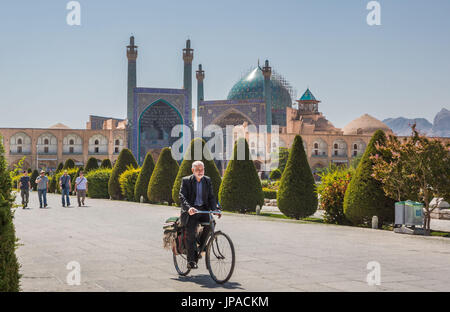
[0,135,21,292]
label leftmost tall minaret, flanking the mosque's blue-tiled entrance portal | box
[127,36,137,150]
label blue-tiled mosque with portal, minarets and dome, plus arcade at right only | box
[127,37,392,176]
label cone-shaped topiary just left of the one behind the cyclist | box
[147,147,179,205]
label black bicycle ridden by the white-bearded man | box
[172,210,236,284]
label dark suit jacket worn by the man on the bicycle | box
[179,174,216,226]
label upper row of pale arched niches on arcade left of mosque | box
[10,132,124,154]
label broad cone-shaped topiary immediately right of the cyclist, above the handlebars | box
[219,138,264,213]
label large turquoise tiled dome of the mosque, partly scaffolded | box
[227,66,292,110]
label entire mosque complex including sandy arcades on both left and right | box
[0,36,400,172]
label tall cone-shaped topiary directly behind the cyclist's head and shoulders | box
[172,138,222,205]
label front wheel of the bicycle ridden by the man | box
[206,231,236,284]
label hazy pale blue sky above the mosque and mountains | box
[0,0,450,128]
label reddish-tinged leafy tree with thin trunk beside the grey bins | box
[371,125,450,234]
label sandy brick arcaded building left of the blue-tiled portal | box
[0,116,127,171]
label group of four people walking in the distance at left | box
[19,170,88,209]
